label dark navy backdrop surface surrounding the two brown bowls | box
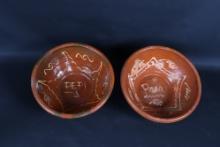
[0,0,220,147]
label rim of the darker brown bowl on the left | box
[31,42,115,119]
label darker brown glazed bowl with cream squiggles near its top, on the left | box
[31,43,114,118]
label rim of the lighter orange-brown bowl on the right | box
[120,45,202,123]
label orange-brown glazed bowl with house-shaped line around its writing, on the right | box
[121,46,201,123]
